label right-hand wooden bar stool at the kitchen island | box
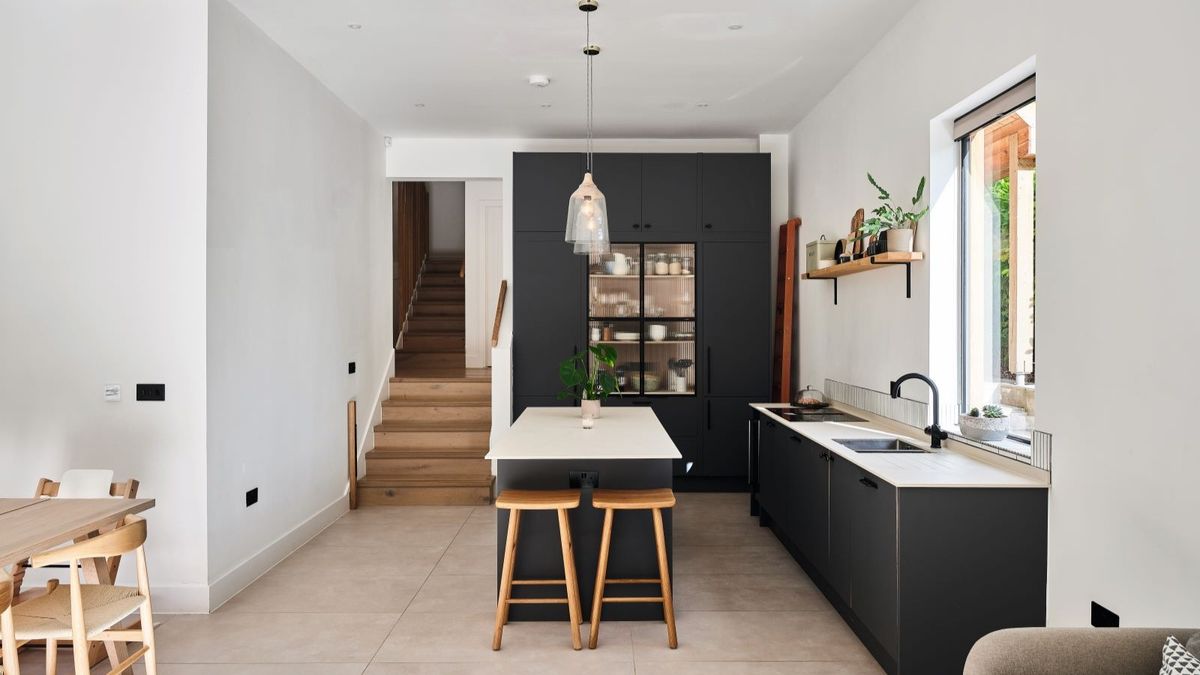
[588,488,679,650]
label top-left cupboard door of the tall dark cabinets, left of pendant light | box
[512,153,583,230]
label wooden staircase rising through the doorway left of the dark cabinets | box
[359,258,493,504]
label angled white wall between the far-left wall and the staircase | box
[208,0,391,607]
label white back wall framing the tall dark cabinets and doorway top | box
[388,137,787,434]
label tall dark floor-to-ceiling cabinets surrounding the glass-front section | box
[512,153,773,489]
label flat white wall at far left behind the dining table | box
[0,0,208,611]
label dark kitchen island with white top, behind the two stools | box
[487,407,682,621]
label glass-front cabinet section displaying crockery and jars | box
[588,244,698,396]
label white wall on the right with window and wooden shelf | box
[791,0,1200,626]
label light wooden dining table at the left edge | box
[0,497,155,664]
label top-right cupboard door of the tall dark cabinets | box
[700,154,770,239]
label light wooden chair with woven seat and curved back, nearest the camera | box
[5,515,157,675]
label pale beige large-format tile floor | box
[22,494,882,675]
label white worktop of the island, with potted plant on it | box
[486,407,683,460]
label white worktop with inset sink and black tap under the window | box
[751,404,1050,488]
